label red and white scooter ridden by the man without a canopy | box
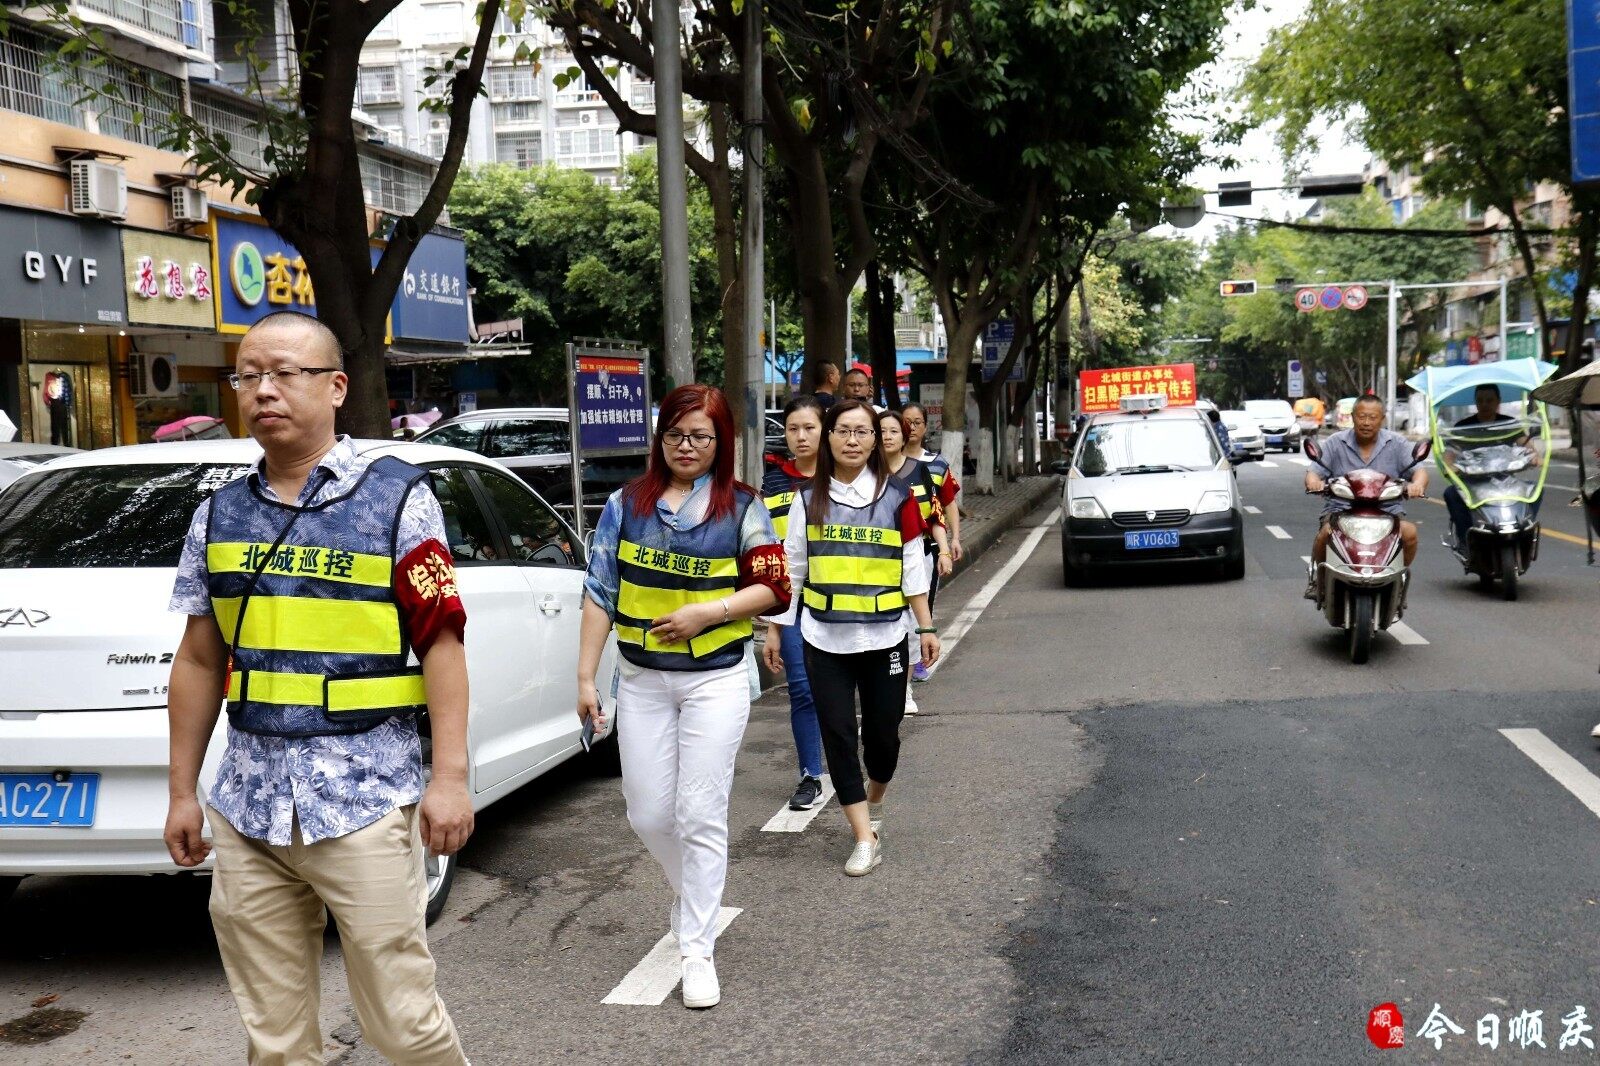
[1306,440,1432,663]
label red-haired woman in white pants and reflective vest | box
[578,384,789,1007]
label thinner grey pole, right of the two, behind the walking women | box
[741,0,764,485]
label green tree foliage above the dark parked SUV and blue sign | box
[450,152,722,402]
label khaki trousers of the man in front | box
[210,805,467,1066]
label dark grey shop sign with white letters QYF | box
[0,206,128,327]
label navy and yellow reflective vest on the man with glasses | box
[206,456,427,736]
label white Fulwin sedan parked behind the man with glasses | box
[0,440,616,919]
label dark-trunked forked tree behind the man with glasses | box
[10,0,531,437]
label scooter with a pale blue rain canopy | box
[1408,359,1555,600]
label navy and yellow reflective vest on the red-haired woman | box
[616,488,760,671]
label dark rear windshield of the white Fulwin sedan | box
[0,463,250,568]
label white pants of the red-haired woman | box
[616,663,750,957]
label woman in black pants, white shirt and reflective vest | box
[761,400,939,877]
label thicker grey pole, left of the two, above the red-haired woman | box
[651,0,694,389]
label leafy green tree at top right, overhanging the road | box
[1243,0,1600,365]
